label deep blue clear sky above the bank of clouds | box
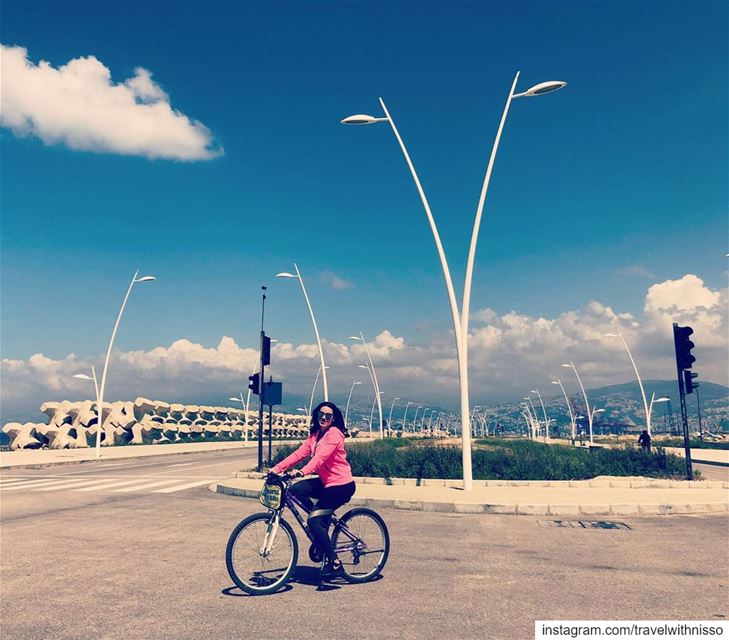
[0,2,729,418]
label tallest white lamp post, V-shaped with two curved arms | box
[341,72,567,491]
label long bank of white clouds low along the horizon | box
[2,274,729,420]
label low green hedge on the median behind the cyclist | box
[274,439,686,480]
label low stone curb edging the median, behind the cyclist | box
[208,482,729,517]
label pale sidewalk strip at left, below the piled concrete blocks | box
[0,440,258,469]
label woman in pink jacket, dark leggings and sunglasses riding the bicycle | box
[271,402,355,577]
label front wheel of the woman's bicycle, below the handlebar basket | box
[225,513,299,595]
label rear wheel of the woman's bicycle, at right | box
[332,507,390,583]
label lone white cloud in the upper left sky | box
[0,45,223,160]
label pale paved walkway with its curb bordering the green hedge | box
[210,472,729,517]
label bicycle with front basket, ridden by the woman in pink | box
[225,473,390,595]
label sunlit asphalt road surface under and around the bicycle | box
[0,451,729,640]
